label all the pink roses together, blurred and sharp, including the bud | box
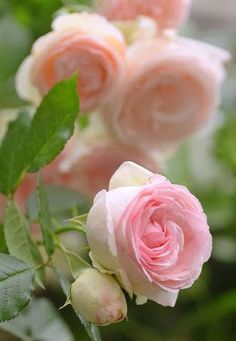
[0,0,226,325]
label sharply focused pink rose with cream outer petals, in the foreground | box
[86,162,212,306]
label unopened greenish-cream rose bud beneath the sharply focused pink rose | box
[71,269,127,326]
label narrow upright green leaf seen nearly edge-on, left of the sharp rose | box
[37,177,55,257]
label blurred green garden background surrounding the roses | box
[0,0,236,341]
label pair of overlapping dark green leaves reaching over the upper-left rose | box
[0,77,79,194]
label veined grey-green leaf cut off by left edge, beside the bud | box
[0,254,35,321]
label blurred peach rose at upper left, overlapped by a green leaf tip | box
[16,13,125,111]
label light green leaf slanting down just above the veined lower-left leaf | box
[4,201,42,266]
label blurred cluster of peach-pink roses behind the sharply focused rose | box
[13,0,229,202]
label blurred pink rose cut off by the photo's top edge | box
[96,0,192,29]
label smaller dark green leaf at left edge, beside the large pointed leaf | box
[0,114,30,194]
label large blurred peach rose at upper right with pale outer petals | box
[105,32,229,148]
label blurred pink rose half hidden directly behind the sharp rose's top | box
[65,140,158,198]
